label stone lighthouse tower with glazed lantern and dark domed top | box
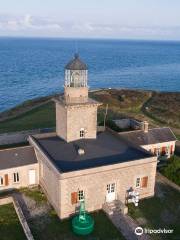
[55,54,100,142]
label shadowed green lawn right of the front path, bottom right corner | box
[129,183,180,240]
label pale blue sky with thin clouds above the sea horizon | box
[0,0,180,40]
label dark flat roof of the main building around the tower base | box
[34,131,152,172]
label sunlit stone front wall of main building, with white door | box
[60,157,157,218]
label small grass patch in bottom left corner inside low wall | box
[0,204,26,240]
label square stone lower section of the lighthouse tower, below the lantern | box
[56,103,98,142]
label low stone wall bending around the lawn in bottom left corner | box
[0,196,34,240]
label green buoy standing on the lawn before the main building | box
[72,200,94,236]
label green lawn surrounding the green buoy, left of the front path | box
[30,210,125,240]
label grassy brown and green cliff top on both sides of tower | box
[0,89,180,139]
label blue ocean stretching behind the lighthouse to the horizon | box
[0,38,180,111]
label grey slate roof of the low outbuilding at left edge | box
[0,146,37,170]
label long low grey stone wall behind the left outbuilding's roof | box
[0,128,54,145]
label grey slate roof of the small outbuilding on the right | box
[119,127,176,146]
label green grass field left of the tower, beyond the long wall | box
[0,102,55,133]
